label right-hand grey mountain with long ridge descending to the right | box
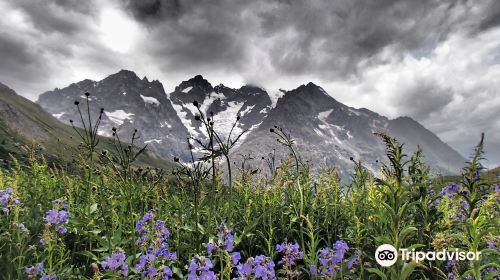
[235,83,465,175]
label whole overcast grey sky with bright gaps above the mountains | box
[0,0,500,165]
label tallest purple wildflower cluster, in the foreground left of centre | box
[135,211,177,280]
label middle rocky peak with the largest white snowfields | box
[170,75,271,140]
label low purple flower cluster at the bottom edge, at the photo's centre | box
[237,255,276,280]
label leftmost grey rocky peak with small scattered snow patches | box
[37,70,188,159]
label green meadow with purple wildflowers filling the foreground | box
[0,99,500,279]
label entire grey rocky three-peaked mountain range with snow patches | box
[38,70,464,176]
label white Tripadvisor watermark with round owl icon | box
[375,244,481,267]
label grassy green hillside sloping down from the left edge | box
[0,83,172,167]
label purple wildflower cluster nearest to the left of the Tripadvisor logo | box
[311,240,350,278]
